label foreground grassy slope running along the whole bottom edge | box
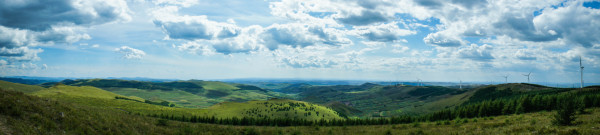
[0,87,600,135]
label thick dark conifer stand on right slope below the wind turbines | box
[419,89,600,121]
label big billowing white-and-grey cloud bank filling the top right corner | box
[411,0,600,47]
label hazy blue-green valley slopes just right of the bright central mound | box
[298,84,465,117]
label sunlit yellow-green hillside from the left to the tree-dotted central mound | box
[2,85,341,120]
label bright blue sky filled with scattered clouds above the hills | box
[0,0,600,83]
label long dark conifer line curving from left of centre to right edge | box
[147,89,600,126]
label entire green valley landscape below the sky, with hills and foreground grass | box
[0,79,600,134]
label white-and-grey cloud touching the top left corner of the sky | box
[0,0,131,31]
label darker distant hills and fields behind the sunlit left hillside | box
[43,79,287,108]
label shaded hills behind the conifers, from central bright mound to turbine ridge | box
[288,83,593,117]
